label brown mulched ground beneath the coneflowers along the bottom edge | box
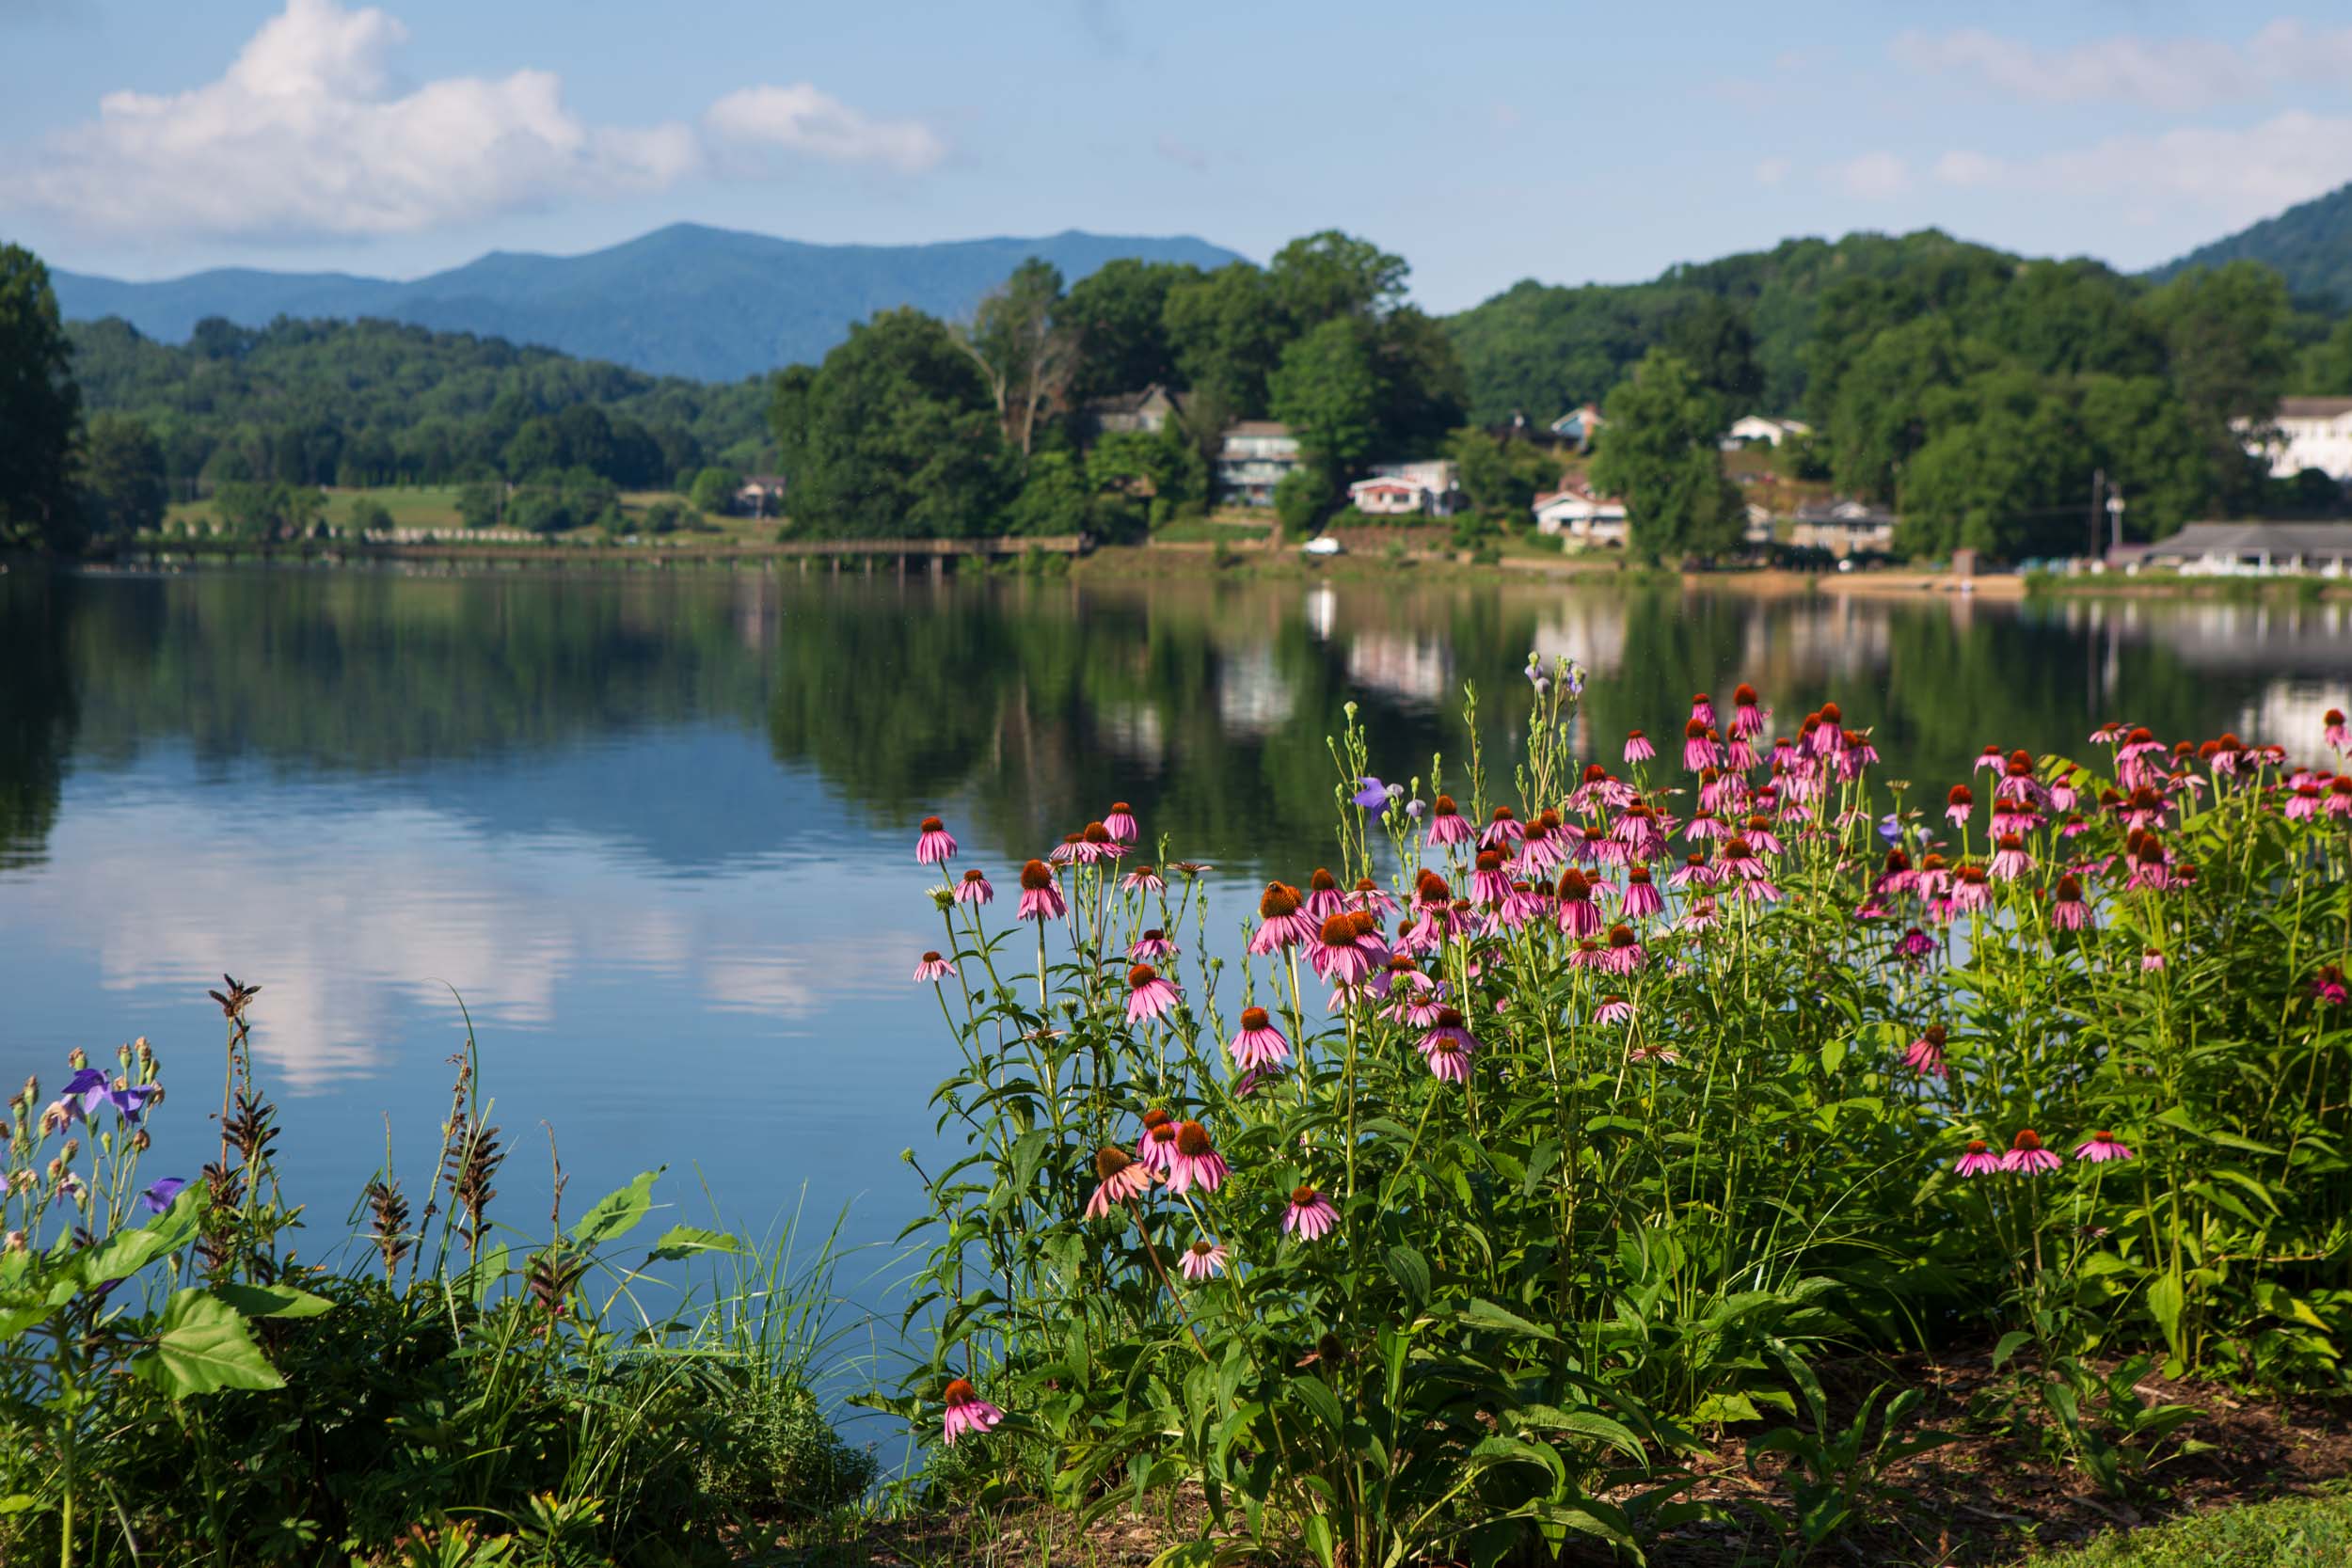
[760,1352,2352,1568]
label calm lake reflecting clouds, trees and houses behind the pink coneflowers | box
[0,569,2352,1300]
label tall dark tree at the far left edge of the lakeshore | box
[0,245,83,550]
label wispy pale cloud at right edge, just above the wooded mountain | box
[1936,110,2352,228]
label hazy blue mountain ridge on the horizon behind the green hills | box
[50,223,1240,381]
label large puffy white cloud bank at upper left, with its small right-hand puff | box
[0,0,941,237]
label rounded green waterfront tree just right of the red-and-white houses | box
[1593,348,1743,562]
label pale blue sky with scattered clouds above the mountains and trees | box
[0,0,2352,310]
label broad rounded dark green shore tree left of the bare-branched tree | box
[771,310,1016,538]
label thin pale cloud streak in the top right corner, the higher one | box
[1894,21,2352,110]
